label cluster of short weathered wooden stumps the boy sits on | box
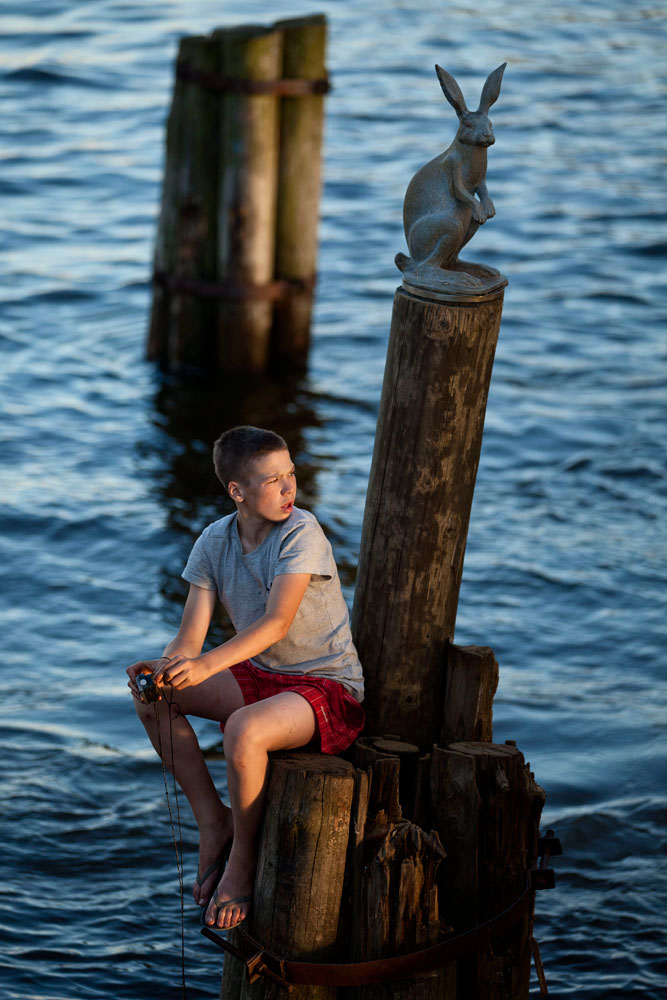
[220,647,544,1000]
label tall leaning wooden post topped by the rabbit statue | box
[352,288,503,749]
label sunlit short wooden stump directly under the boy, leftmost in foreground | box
[220,752,355,1000]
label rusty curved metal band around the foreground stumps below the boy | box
[202,879,535,990]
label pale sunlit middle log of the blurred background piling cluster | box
[216,25,283,373]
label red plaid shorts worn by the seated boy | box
[226,660,366,754]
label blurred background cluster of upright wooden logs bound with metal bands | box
[148,15,326,374]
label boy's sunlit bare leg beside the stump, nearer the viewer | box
[206,691,316,927]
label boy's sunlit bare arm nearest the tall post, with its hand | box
[155,573,311,688]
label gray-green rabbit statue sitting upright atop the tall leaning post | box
[395,63,507,294]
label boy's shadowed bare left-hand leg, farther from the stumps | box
[135,670,243,906]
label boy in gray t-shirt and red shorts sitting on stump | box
[127,427,364,928]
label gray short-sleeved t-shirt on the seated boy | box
[182,507,364,701]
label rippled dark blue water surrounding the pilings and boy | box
[0,0,667,1000]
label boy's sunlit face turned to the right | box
[229,449,296,522]
